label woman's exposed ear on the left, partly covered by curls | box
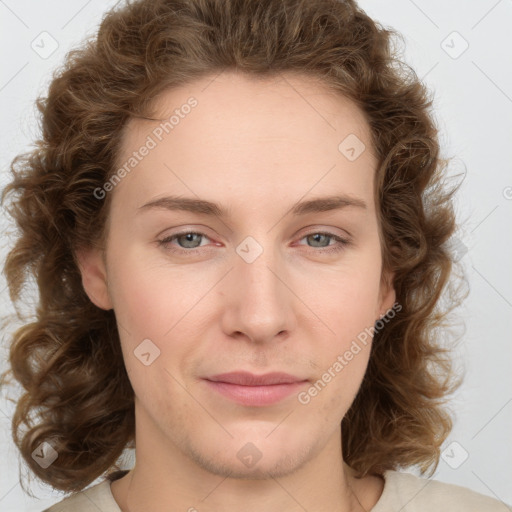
[75,248,113,310]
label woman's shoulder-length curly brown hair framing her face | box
[2,0,468,498]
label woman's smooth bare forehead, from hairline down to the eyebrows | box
[111,72,375,214]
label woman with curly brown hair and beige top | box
[4,0,506,512]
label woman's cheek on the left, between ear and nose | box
[109,250,211,382]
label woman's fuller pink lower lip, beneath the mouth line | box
[205,380,307,406]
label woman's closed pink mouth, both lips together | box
[204,372,308,407]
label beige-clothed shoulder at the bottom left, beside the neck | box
[42,479,121,512]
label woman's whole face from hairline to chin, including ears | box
[81,73,395,478]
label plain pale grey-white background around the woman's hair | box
[0,0,512,512]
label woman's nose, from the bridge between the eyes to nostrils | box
[222,239,299,344]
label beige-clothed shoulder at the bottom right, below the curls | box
[371,471,512,512]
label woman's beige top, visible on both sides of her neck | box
[43,470,512,512]
